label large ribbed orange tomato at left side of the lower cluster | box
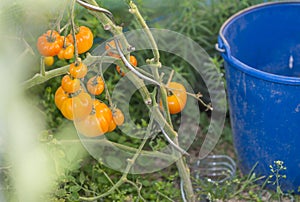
[55,87,93,120]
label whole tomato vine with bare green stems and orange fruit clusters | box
[24,0,213,201]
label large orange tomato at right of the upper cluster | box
[67,26,94,54]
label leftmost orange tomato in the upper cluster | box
[37,30,63,57]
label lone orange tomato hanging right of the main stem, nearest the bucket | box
[160,82,187,114]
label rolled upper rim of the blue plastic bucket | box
[217,0,300,85]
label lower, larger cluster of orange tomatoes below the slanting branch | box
[55,62,124,137]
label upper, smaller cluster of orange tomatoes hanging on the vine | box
[37,26,94,66]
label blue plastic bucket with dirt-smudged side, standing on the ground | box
[217,1,300,192]
